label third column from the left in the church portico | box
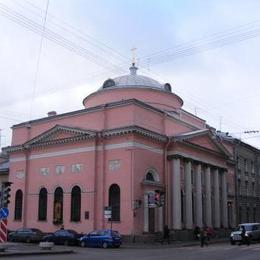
[195,164,203,227]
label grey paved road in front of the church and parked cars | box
[1,244,260,260]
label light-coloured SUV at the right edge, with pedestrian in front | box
[230,223,260,245]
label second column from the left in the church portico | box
[184,161,193,229]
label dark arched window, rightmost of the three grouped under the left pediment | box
[70,186,81,222]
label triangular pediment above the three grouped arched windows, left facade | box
[24,125,96,146]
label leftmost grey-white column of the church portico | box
[172,158,181,229]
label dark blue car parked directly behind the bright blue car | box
[42,229,82,246]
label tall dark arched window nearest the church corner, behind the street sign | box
[109,184,120,221]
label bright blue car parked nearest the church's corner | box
[79,229,122,248]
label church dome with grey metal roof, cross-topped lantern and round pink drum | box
[83,63,183,111]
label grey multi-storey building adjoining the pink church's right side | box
[218,133,260,223]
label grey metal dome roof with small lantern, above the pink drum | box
[102,64,171,92]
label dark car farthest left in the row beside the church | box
[8,228,44,243]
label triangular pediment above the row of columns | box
[172,129,232,157]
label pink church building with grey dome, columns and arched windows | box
[5,64,235,235]
